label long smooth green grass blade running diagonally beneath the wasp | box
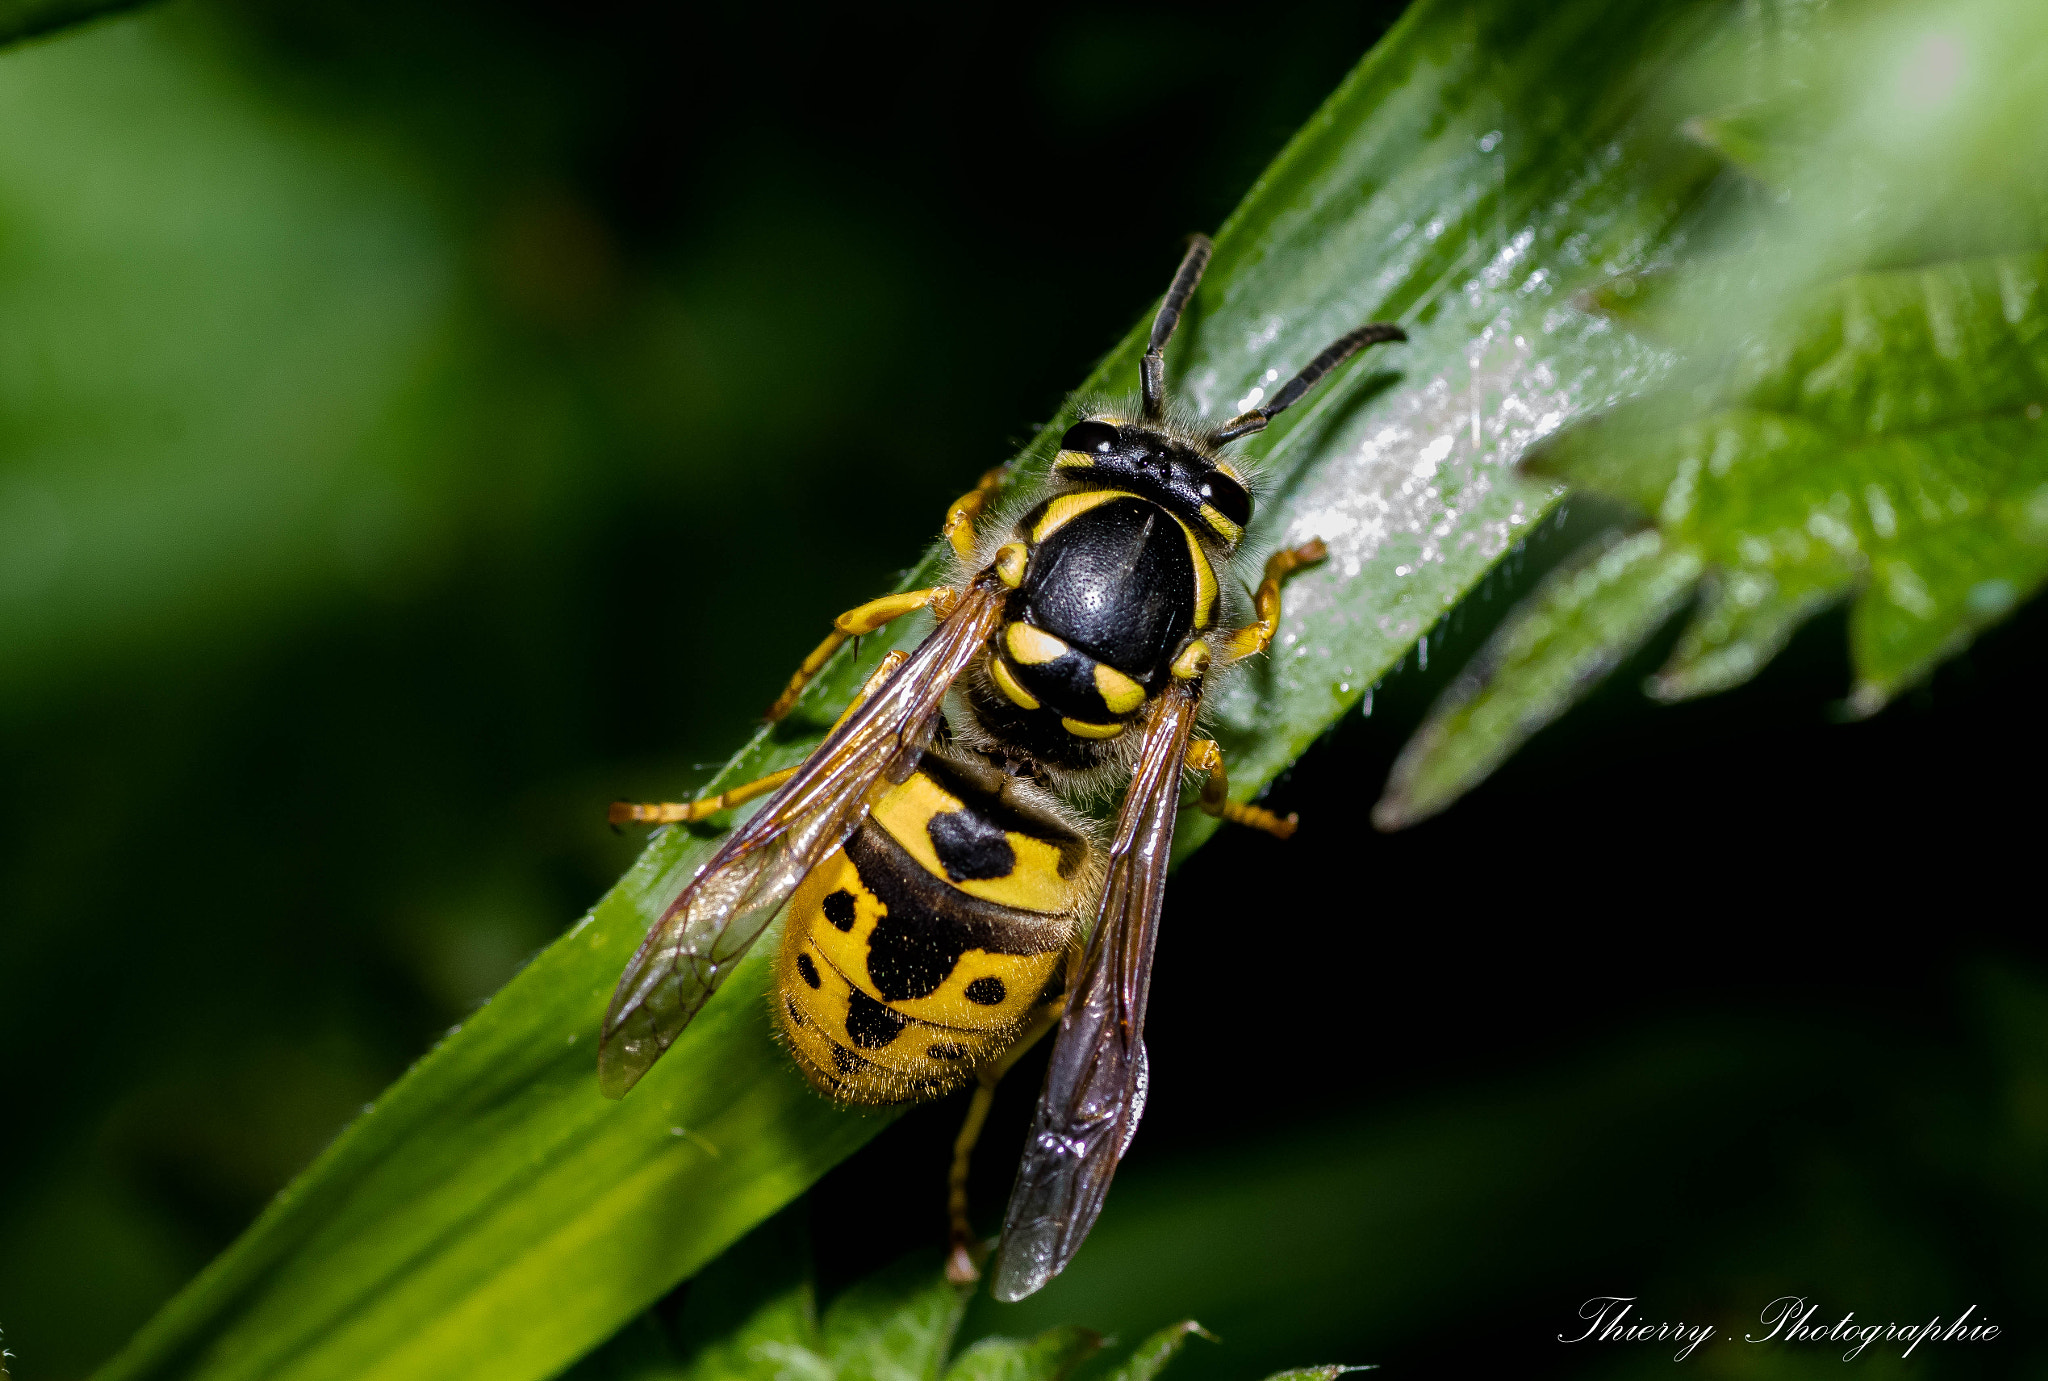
[102,0,1722,1381]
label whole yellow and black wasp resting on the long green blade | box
[598,236,1407,1301]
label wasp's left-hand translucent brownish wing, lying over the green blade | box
[598,586,1001,1098]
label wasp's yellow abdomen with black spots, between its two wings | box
[776,754,1087,1102]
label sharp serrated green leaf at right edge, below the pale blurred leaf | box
[1564,252,2048,713]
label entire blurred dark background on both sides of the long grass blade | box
[0,0,2048,1379]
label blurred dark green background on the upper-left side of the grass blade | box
[0,2,1391,1377]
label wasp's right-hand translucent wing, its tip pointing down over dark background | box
[993,686,1196,1301]
